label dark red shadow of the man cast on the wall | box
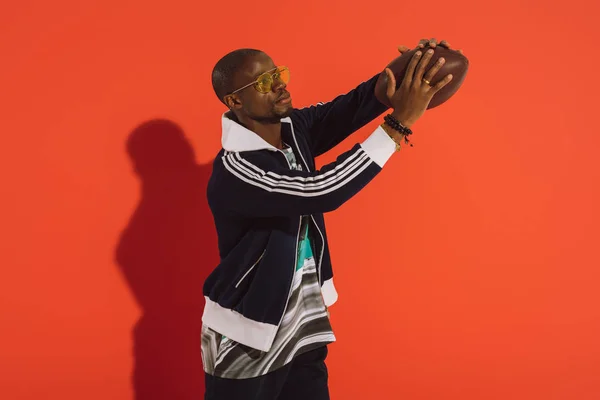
[116,120,219,400]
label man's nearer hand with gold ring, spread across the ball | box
[385,49,452,128]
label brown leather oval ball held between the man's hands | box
[375,46,469,110]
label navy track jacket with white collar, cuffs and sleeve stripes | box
[202,75,396,351]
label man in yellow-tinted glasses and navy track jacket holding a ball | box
[202,40,452,400]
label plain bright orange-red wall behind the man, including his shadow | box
[0,0,600,400]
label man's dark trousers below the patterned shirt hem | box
[204,346,329,400]
